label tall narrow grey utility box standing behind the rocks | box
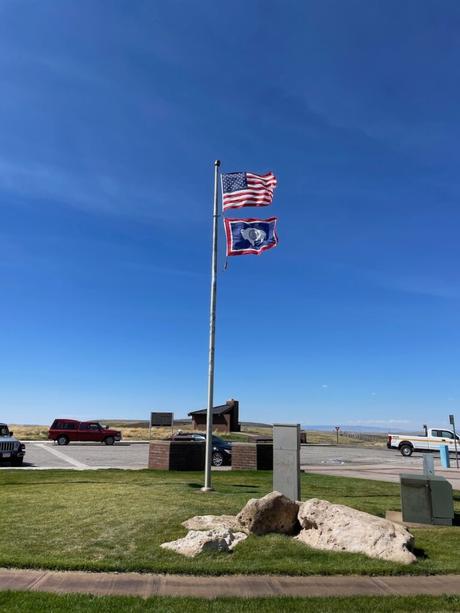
[273,424,300,500]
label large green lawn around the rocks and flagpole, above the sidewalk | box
[0,470,460,574]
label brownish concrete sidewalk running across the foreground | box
[0,569,460,598]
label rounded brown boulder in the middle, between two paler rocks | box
[236,492,299,535]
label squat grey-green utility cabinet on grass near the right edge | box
[399,474,454,526]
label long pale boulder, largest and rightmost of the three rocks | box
[297,498,416,564]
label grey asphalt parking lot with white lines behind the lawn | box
[2,441,460,489]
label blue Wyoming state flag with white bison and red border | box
[224,217,278,255]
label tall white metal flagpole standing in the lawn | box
[201,160,220,492]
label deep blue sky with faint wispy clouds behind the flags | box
[0,0,460,430]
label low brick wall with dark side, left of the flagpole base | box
[149,441,205,470]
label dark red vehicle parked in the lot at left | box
[48,419,121,445]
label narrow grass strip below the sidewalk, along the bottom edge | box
[0,592,460,613]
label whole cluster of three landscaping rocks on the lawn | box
[161,492,417,564]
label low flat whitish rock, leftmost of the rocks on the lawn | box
[161,529,247,558]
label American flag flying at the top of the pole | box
[222,172,277,211]
